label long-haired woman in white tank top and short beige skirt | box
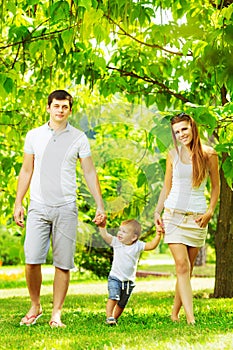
[154,113,220,324]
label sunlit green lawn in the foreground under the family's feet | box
[0,290,233,350]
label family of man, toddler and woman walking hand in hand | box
[14,90,219,328]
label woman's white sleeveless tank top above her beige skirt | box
[164,149,207,213]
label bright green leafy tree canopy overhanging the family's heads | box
[0,0,233,294]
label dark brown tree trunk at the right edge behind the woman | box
[213,154,233,298]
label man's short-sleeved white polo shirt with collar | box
[24,123,91,206]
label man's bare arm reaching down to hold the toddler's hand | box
[80,157,106,225]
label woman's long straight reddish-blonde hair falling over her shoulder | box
[171,113,208,187]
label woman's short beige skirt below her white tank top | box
[163,209,208,247]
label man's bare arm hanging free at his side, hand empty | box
[14,153,34,227]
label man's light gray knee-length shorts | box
[24,201,78,270]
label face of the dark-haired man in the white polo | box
[47,98,71,125]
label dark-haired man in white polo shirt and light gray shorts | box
[14,90,106,327]
